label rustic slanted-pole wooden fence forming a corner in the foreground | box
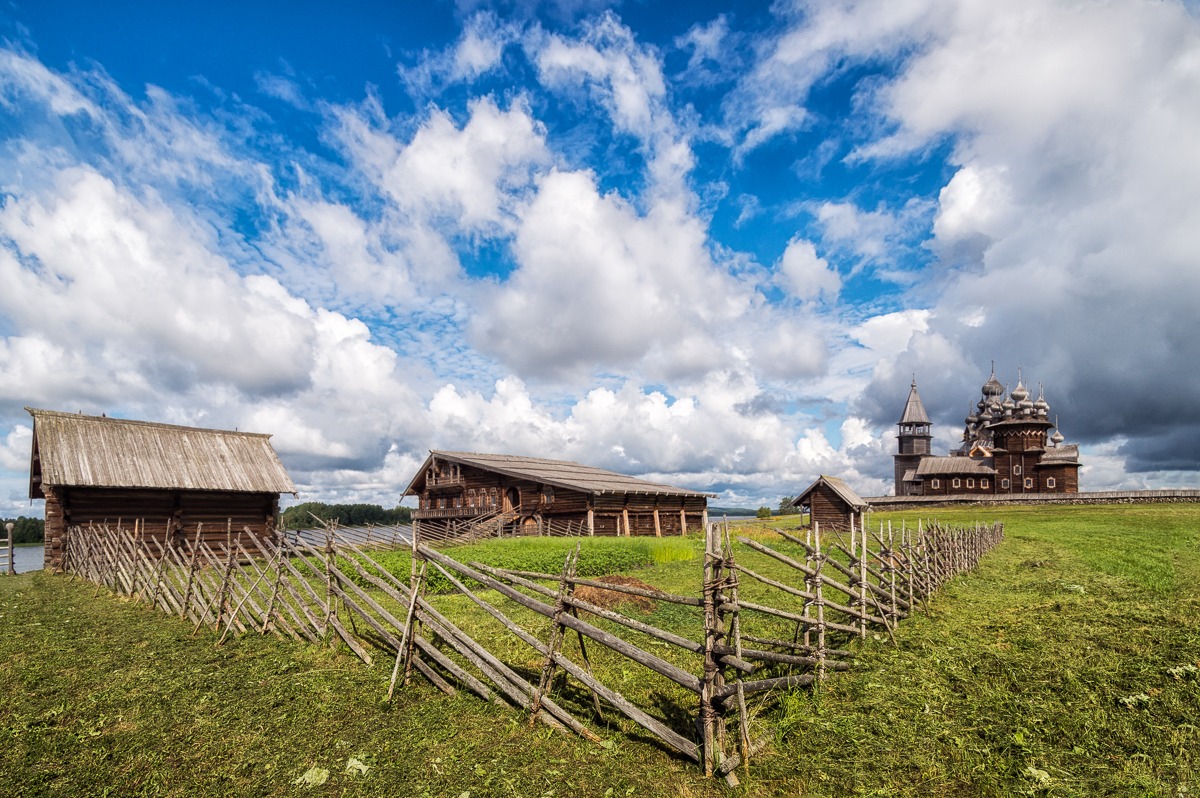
[64,513,1003,785]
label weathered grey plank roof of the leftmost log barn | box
[25,407,296,498]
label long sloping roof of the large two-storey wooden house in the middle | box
[404,449,716,498]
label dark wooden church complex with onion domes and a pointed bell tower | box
[893,368,1080,497]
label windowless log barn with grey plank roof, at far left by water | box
[25,408,296,569]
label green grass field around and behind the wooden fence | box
[0,505,1200,798]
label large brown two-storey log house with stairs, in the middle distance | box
[404,451,712,539]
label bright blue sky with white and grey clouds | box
[0,0,1200,515]
